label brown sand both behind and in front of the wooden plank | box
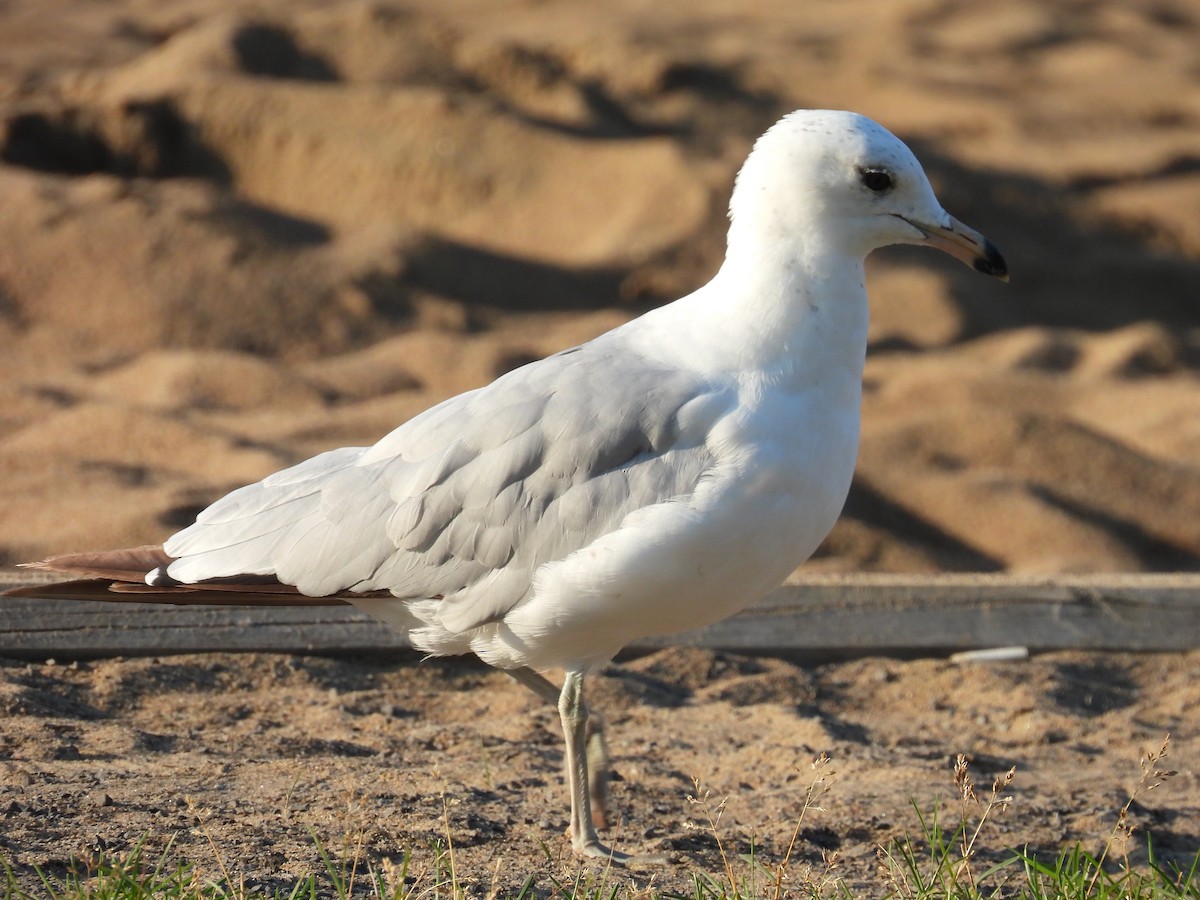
[0,0,1200,886]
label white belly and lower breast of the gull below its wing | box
[472,398,858,668]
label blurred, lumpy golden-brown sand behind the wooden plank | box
[0,0,1200,571]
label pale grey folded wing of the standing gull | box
[164,336,734,631]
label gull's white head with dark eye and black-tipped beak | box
[730,109,1008,281]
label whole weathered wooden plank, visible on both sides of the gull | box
[0,571,1200,659]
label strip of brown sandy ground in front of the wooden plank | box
[0,649,1200,896]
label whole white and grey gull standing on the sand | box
[11,110,1008,864]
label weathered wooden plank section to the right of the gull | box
[646,575,1200,655]
